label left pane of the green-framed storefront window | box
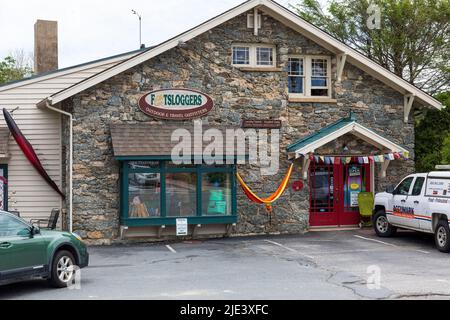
[128,173,161,218]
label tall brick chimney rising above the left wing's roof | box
[34,20,58,74]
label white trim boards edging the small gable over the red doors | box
[292,122,409,159]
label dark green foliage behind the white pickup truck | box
[416,91,450,172]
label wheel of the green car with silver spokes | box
[50,250,76,288]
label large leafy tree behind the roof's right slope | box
[293,0,450,95]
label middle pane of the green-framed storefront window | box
[166,173,197,217]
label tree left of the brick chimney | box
[0,51,33,84]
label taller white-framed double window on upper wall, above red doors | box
[288,56,331,97]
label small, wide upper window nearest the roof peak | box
[232,44,276,68]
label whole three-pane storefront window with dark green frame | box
[121,161,236,226]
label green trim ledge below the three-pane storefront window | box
[122,216,238,227]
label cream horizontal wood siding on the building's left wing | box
[0,60,129,220]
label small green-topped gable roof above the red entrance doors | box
[287,113,409,158]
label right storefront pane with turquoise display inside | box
[202,173,232,216]
